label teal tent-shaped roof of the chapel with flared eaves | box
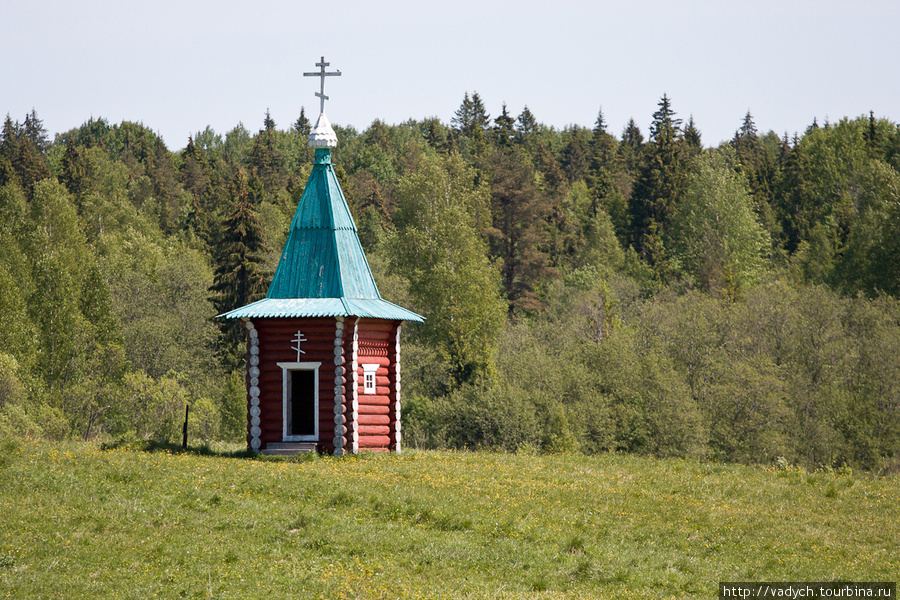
[219,148,423,322]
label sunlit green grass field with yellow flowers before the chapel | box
[0,443,900,599]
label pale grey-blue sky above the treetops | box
[0,0,900,150]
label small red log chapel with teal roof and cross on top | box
[220,57,423,456]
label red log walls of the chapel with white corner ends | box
[245,317,400,455]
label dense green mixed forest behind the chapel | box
[0,92,900,473]
